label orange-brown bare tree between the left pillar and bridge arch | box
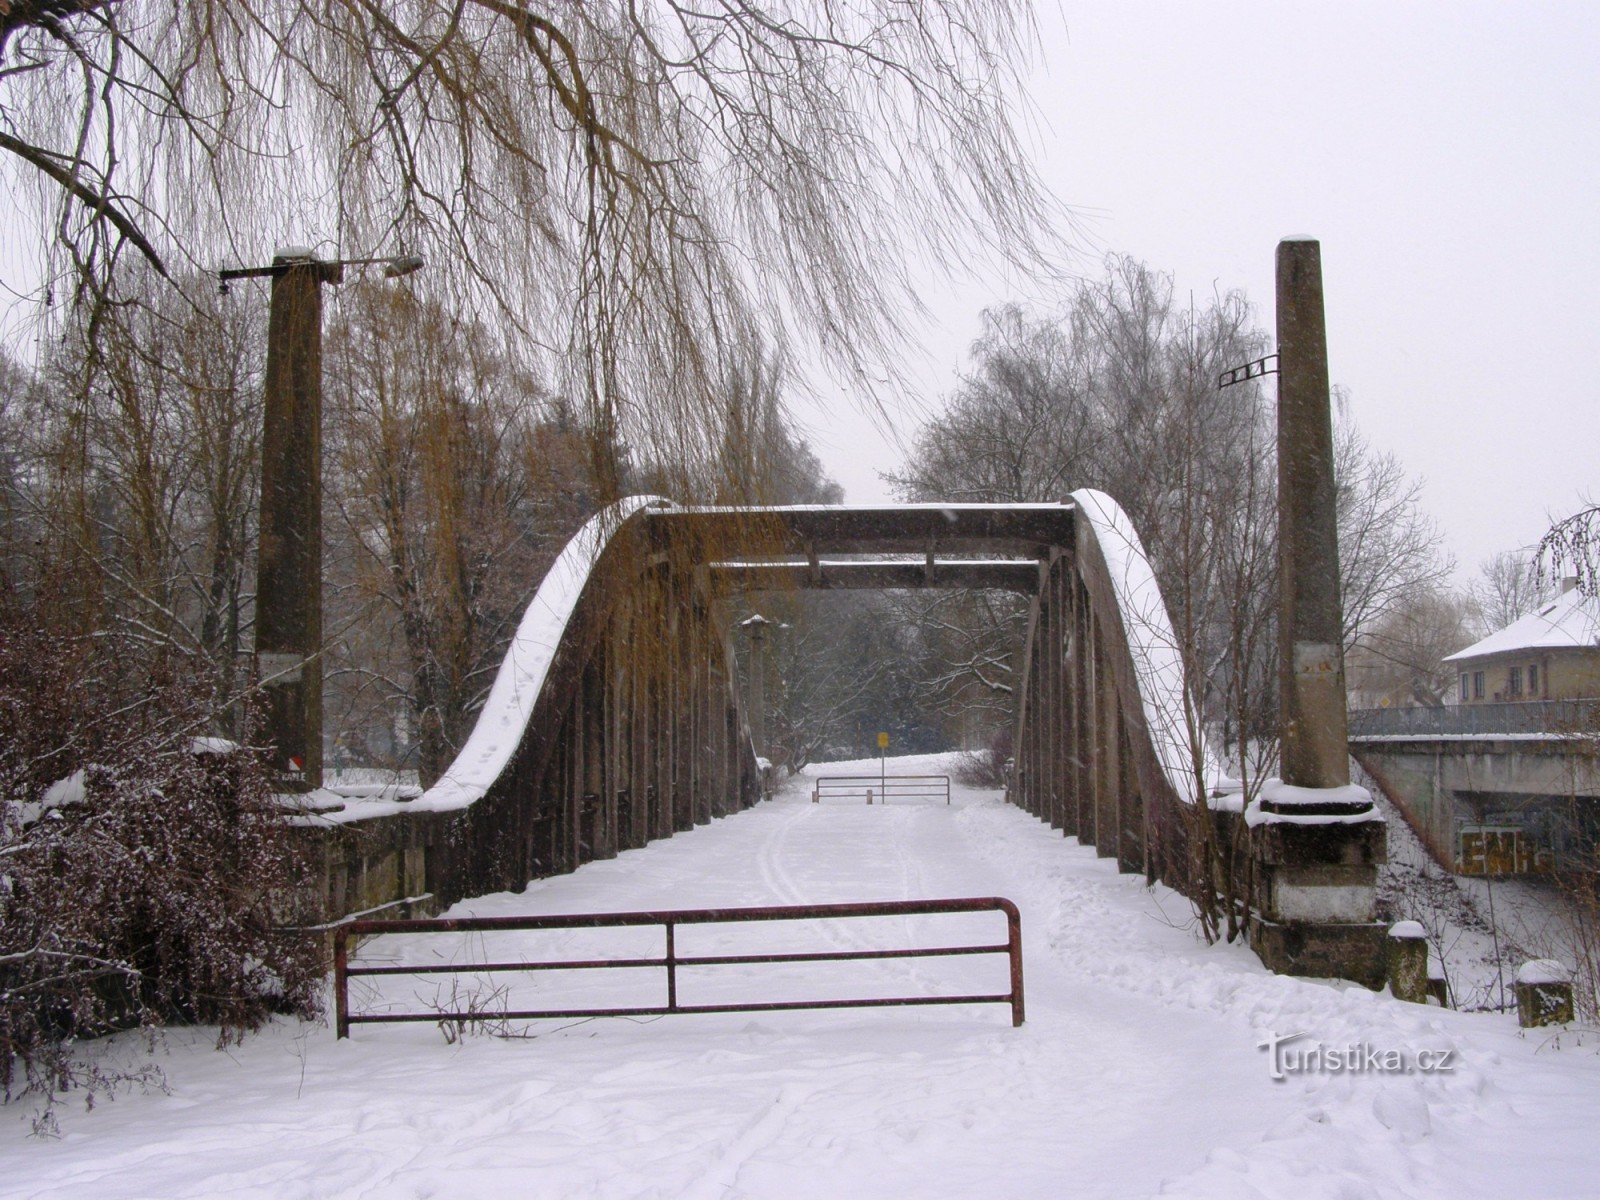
[326,288,579,782]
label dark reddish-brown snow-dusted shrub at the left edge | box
[0,597,320,1099]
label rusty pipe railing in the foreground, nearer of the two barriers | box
[333,896,1024,1038]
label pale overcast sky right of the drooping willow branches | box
[802,0,1600,578]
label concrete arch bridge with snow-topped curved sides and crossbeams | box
[307,491,1382,981]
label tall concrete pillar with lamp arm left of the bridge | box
[218,246,424,790]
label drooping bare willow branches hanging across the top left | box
[0,0,1059,496]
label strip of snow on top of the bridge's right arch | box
[1072,488,1229,802]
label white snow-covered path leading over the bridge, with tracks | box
[9,760,1600,1200]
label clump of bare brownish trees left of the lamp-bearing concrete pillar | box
[0,278,261,693]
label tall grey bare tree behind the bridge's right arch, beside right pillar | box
[891,256,1275,771]
